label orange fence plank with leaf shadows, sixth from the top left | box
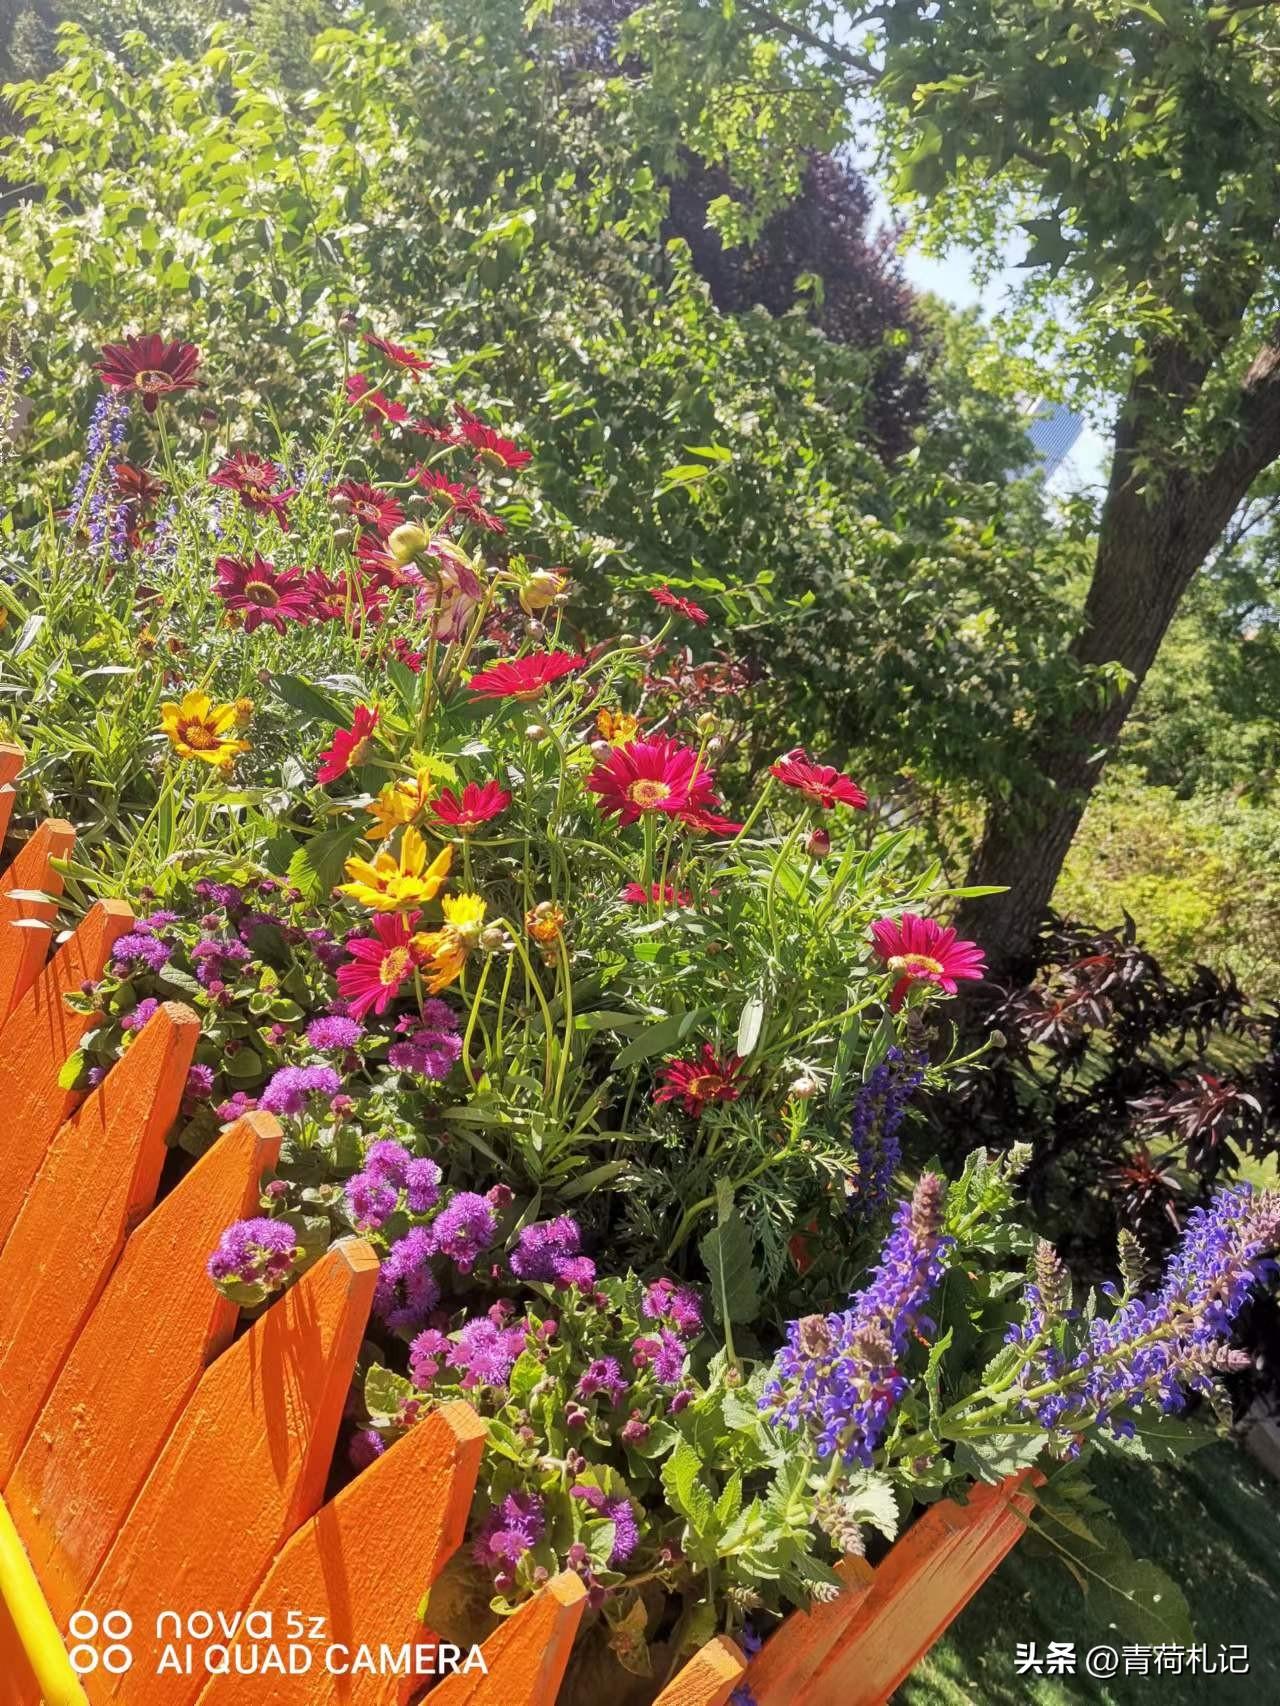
[85,1239,377,1706]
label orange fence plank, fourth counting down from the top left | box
[0,1001,200,1486]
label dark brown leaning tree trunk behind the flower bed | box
[957,346,1280,976]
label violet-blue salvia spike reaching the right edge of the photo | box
[1009,1184,1280,1452]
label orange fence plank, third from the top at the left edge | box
[0,901,133,1245]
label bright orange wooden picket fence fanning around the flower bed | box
[0,747,1029,1706]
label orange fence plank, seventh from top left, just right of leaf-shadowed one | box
[200,1404,486,1706]
